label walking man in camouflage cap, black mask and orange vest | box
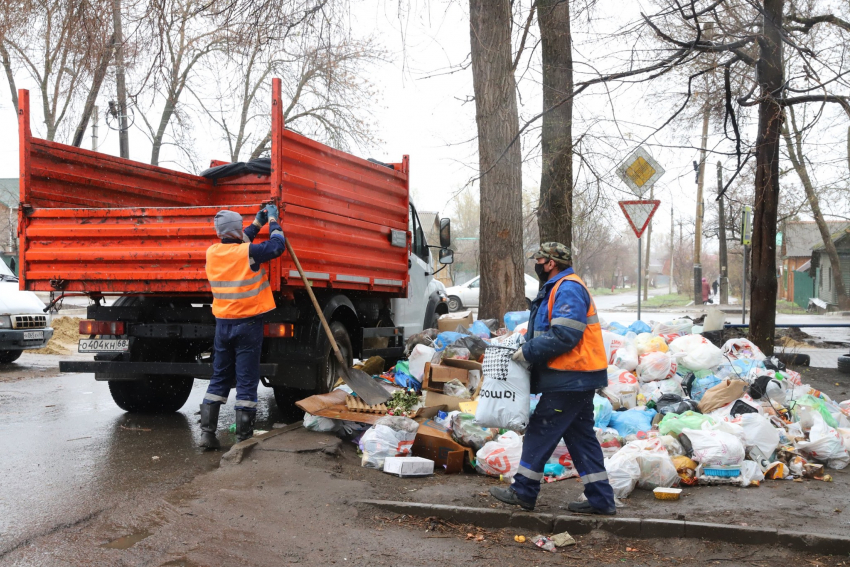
[490,242,616,515]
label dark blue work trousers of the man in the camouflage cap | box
[513,390,615,510]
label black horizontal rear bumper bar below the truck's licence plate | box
[59,360,277,381]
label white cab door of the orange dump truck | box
[392,205,433,339]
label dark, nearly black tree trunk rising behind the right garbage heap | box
[749,0,785,355]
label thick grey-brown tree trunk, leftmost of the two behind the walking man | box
[469,0,525,319]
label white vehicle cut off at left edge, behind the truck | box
[0,260,53,364]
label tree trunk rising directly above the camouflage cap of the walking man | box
[537,0,573,247]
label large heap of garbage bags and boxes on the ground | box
[304,311,850,498]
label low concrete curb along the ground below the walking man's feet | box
[357,500,850,555]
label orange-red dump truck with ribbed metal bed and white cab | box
[19,80,451,412]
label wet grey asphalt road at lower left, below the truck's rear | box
[0,364,288,559]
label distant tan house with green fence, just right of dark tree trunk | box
[777,221,848,308]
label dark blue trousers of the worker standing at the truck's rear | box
[204,315,263,411]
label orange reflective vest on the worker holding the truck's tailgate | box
[206,242,275,319]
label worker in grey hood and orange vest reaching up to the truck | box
[201,205,286,449]
